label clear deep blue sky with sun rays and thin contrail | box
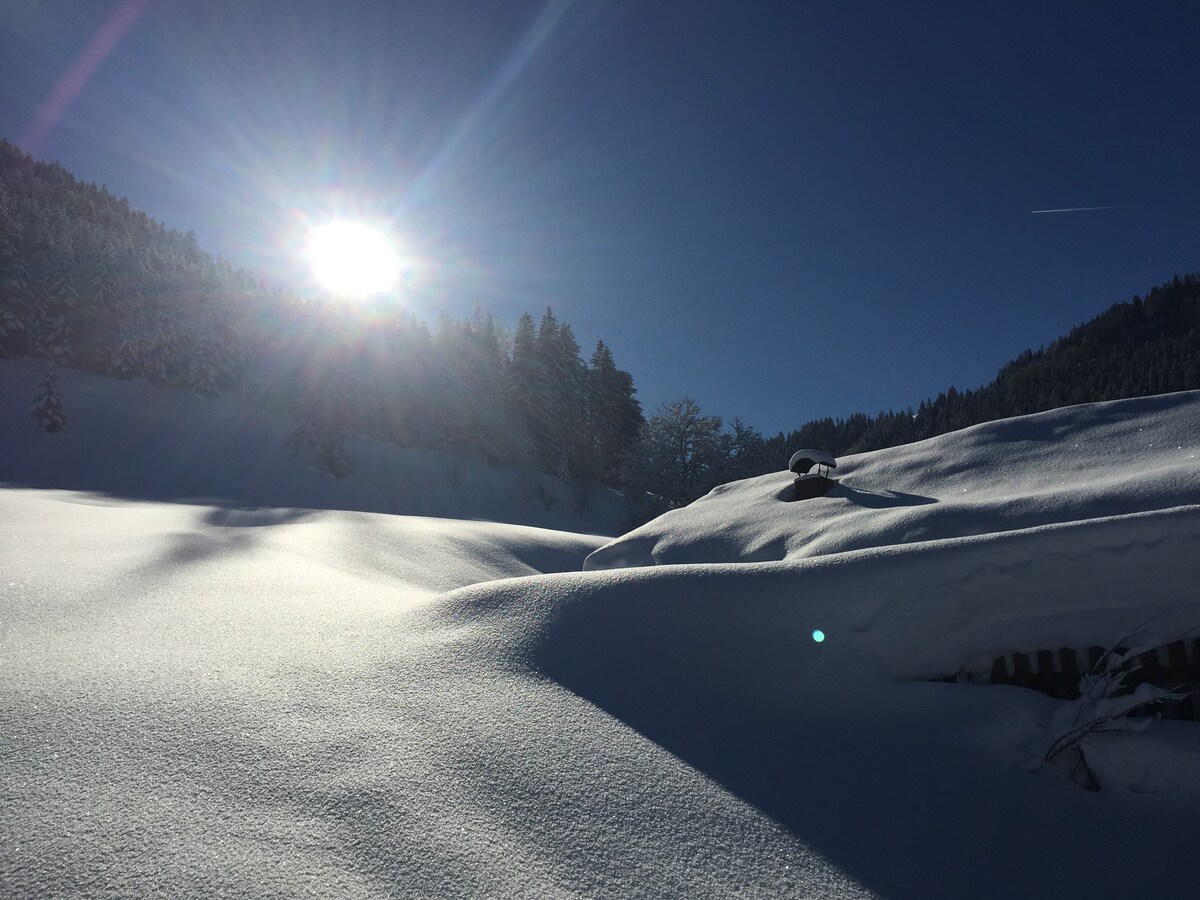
[0,0,1200,433]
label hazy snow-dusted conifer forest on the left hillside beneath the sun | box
[0,142,642,494]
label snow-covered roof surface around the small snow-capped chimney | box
[584,391,1200,570]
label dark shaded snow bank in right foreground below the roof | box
[431,496,1200,898]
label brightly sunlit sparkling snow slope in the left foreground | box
[0,490,863,898]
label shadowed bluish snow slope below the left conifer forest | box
[0,361,624,535]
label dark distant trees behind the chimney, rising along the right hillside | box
[609,274,1200,522]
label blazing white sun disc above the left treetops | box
[306,221,401,298]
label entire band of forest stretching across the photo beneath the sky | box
[0,140,1200,523]
